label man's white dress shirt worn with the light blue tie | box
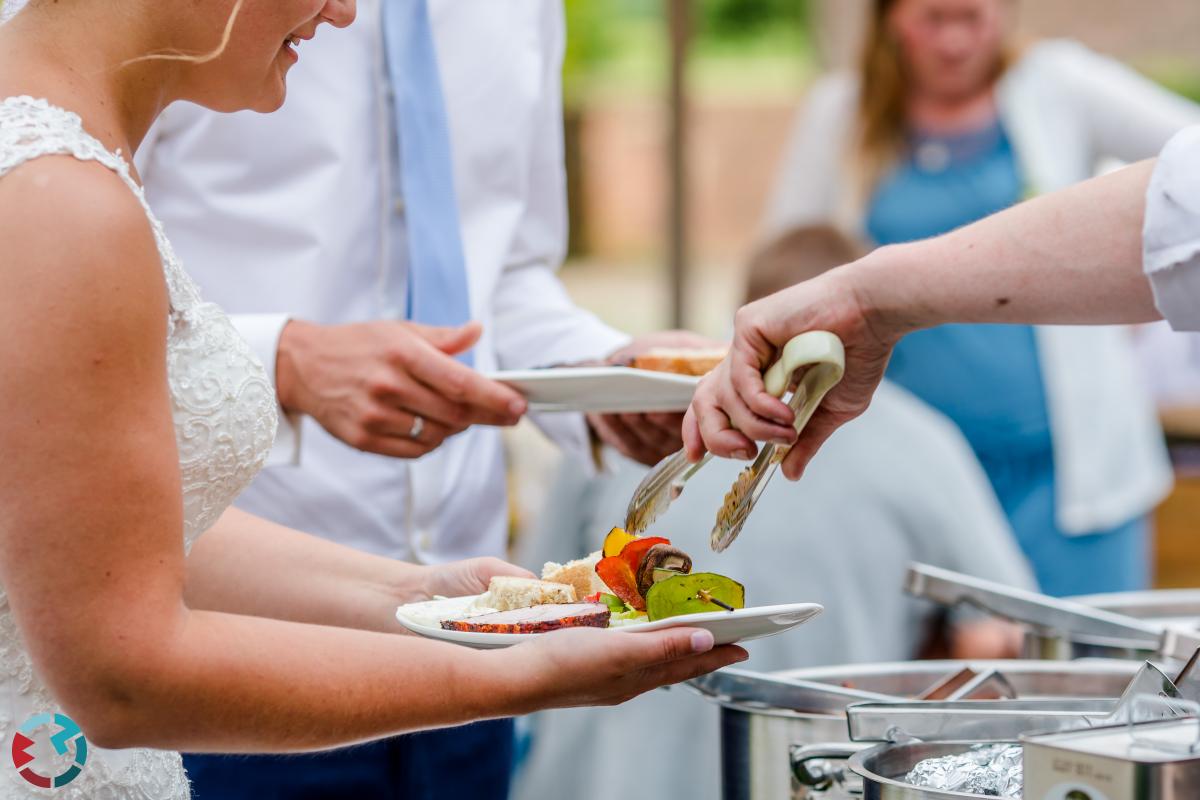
[138,0,626,563]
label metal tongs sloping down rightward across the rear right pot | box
[905,564,1200,661]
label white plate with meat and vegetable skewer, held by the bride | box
[396,597,824,650]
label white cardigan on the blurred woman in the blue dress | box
[763,41,1200,535]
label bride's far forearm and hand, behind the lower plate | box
[184,509,529,632]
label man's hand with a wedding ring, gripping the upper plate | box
[275,320,527,458]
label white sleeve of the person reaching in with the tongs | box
[1142,126,1200,331]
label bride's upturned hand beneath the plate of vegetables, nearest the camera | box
[488,627,748,714]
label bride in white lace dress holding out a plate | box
[0,0,745,800]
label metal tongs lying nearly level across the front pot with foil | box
[846,661,1193,742]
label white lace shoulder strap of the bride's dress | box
[0,96,200,321]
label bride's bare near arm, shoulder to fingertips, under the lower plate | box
[0,164,744,752]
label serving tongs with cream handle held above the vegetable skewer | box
[625,331,846,553]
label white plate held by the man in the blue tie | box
[487,367,700,414]
